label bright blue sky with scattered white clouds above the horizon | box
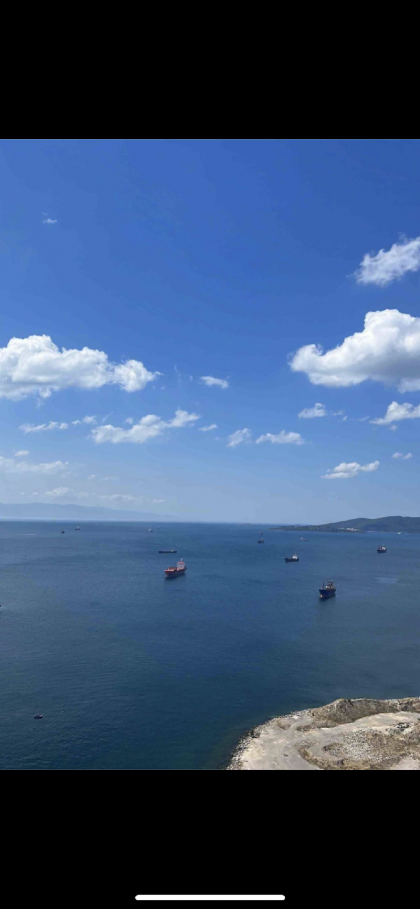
[0,139,420,523]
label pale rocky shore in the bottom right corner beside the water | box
[226,698,420,770]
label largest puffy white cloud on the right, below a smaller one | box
[290,309,420,392]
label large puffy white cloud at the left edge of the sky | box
[0,335,160,401]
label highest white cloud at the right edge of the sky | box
[355,237,420,287]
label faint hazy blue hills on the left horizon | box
[0,502,177,523]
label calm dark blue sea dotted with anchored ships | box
[0,523,420,770]
